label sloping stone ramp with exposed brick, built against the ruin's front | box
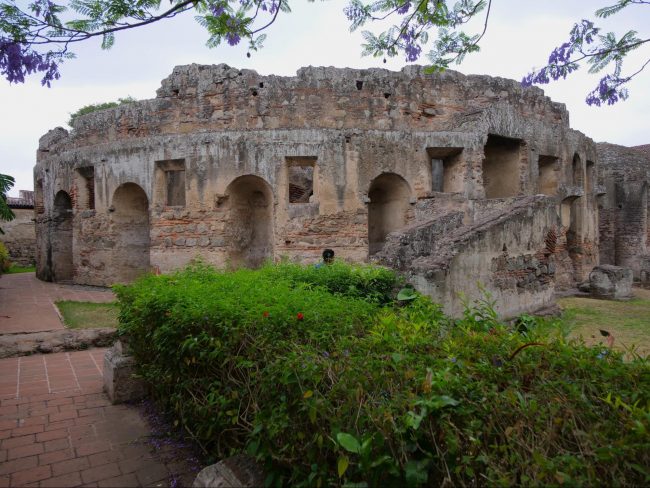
[373,195,565,318]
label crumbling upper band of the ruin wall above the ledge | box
[57,64,569,150]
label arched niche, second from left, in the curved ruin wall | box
[110,183,150,283]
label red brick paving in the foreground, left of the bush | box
[0,350,196,488]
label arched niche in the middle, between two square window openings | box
[226,175,273,268]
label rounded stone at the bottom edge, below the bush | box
[192,454,265,488]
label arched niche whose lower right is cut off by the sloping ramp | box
[368,173,411,255]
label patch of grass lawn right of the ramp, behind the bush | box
[558,288,650,356]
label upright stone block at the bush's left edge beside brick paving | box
[104,341,146,405]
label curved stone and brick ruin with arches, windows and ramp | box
[34,64,648,317]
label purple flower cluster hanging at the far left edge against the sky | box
[0,37,61,87]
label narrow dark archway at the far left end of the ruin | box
[51,190,74,282]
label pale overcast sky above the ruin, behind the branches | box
[0,0,650,196]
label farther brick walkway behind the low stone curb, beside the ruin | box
[0,273,115,334]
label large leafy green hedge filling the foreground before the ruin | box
[117,264,650,486]
